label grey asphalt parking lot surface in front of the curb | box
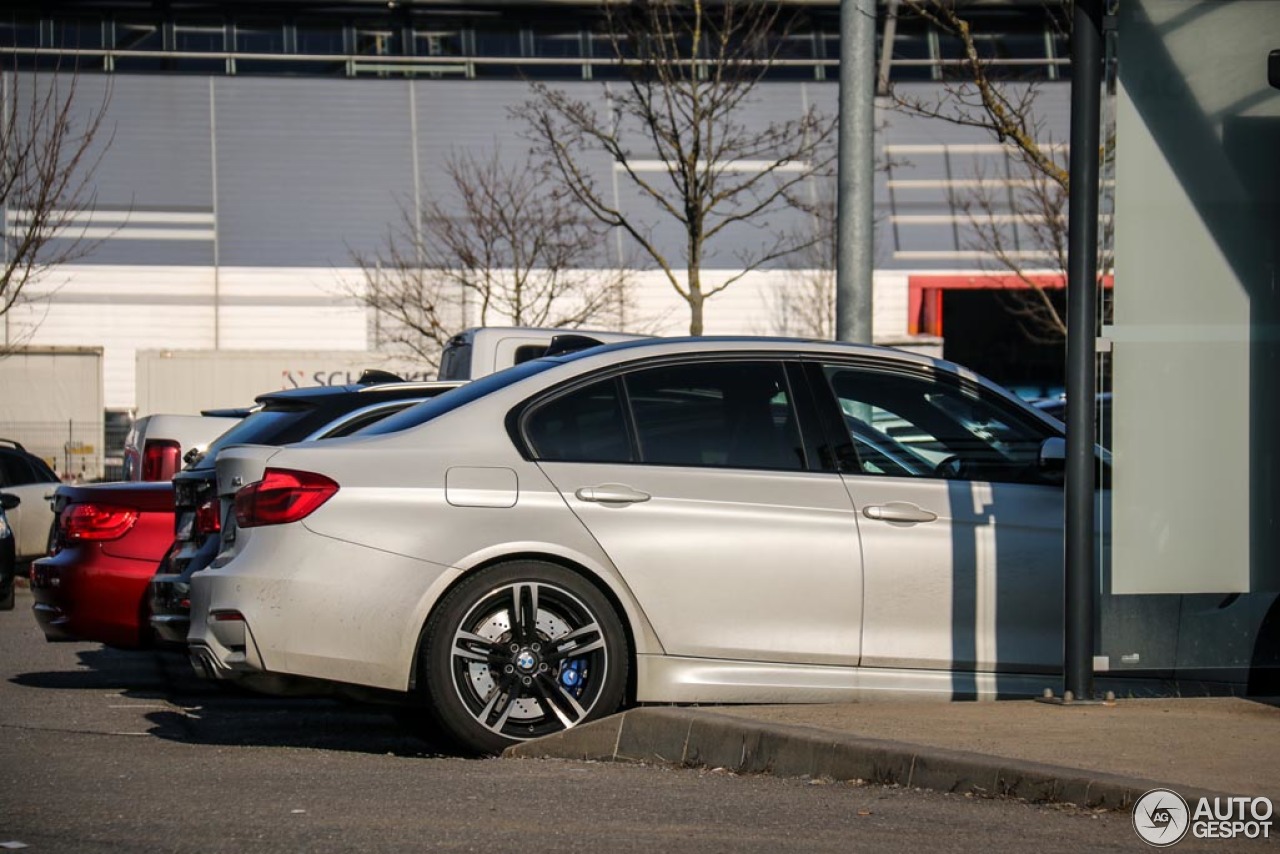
[0,590,1259,853]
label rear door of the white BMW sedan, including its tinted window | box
[522,360,861,665]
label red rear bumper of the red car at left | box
[31,545,156,649]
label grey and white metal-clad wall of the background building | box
[8,74,1069,407]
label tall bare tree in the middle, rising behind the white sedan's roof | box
[515,0,836,335]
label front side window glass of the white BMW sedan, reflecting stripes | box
[823,365,1053,483]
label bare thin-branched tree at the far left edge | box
[0,64,111,356]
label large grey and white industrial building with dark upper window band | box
[0,0,1069,427]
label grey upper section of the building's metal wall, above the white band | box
[32,74,1069,269]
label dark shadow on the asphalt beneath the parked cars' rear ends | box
[9,647,465,757]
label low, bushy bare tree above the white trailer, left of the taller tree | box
[353,151,628,365]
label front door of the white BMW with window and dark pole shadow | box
[810,361,1064,673]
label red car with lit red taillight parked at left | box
[31,481,174,649]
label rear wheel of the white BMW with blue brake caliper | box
[417,561,631,753]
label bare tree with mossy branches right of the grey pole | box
[888,0,1112,342]
